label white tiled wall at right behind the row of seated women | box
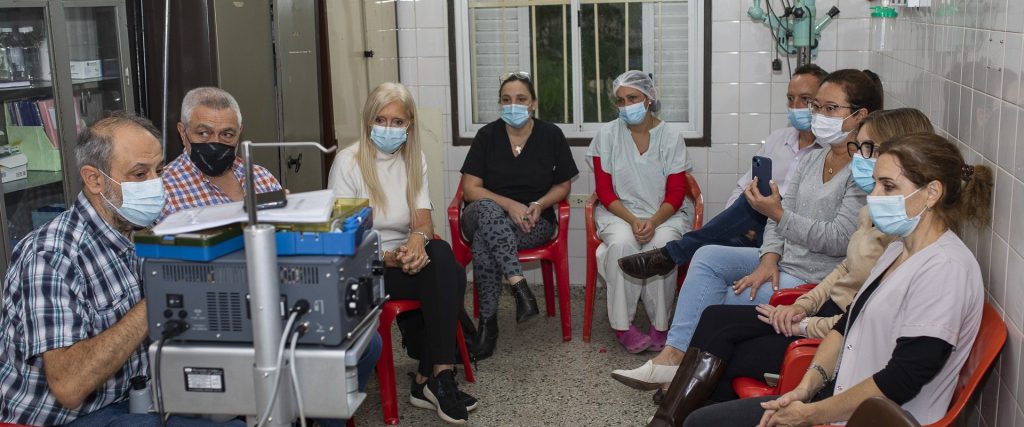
[870,0,1024,421]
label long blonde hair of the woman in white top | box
[355,82,423,220]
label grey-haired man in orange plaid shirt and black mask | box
[162,87,281,216]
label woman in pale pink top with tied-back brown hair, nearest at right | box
[684,133,992,427]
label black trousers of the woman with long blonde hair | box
[384,240,466,377]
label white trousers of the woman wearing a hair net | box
[594,206,689,331]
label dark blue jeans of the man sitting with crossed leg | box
[665,197,768,265]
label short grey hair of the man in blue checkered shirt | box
[75,111,161,173]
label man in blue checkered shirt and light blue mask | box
[0,113,241,425]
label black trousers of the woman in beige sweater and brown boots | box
[690,300,842,401]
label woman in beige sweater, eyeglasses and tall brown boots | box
[655,105,934,425]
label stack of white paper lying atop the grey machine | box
[153,189,334,236]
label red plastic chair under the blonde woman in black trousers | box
[377,300,476,425]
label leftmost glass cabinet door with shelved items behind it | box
[0,6,67,269]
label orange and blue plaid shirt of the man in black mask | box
[161,149,281,219]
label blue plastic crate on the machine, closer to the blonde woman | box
[275,208,373,255]
